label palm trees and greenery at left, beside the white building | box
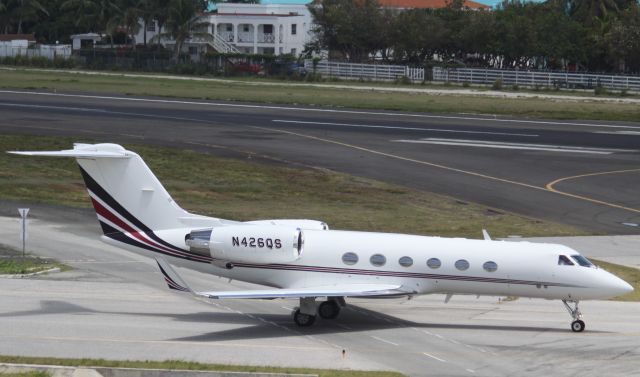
[0,0,207,57]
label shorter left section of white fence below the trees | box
[304,59,424,82]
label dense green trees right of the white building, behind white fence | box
[308,0,640,73]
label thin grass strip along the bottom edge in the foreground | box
[0,351,404,377]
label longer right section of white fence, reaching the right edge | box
[433,67,640,92]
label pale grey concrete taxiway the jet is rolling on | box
[0,211,640,376]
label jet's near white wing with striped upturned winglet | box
[156,258,416,299]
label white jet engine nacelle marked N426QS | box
[185,225,304,268]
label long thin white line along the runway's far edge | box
[5,90,640,130]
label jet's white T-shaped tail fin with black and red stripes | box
[9,144,191,234]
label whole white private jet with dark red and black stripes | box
[10,144,633,332]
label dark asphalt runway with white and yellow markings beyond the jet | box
[0,90,640,234]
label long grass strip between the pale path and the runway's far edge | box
[0,69,640,121]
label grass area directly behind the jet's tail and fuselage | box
[0,135,585,238]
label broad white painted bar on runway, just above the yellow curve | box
[391,138,637,154]
